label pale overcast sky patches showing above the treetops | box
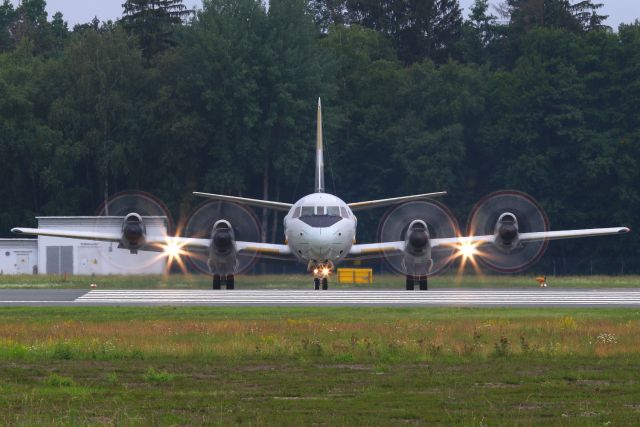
[8,0,640,29]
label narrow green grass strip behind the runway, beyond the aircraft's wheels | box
[0,273,640,289]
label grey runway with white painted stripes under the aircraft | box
[0,288,640,307]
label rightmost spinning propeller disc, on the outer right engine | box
[467,190,549,273]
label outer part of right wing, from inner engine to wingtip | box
[430,227,630,248]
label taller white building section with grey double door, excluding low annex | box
[38,217,167,275]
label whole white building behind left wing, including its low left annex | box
[0,216,167,275]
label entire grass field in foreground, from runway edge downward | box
[0,307,640,426]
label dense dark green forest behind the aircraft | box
[0,0,640,274]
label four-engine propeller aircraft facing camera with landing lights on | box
[12,100,629,290]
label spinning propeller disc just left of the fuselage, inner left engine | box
[183,201,261,274]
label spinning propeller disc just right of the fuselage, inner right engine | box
[378,200,459,276]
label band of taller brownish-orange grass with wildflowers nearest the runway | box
[0,315,640,361]
